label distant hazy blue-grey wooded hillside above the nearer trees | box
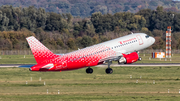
[0,0,177,17]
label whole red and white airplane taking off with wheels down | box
[26,33,155,74]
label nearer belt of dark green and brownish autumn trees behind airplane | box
[0,5,180,50]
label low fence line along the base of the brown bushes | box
[0,49,180,55]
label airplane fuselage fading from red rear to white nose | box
[31,33,155,71]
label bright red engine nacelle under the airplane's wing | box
[118,52,139,64]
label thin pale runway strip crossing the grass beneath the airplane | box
[0,63,180,68]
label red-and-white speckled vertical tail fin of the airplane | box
[26,36,58,64]
